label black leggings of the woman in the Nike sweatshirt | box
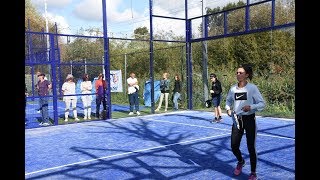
[231,114,257,172]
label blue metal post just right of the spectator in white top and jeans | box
[149,0,155,114]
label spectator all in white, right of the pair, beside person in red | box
[80,74,92,120]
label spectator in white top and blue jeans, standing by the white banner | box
[127,72,140,115]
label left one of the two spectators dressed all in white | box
[62,74,79,122]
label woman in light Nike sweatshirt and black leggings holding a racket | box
[225,64,266,180]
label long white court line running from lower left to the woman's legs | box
[25,133,230,176]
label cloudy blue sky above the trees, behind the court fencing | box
[31,0,243,38]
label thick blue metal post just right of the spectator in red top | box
[102,0,111,119]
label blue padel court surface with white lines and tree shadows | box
[25,110,295,180]
